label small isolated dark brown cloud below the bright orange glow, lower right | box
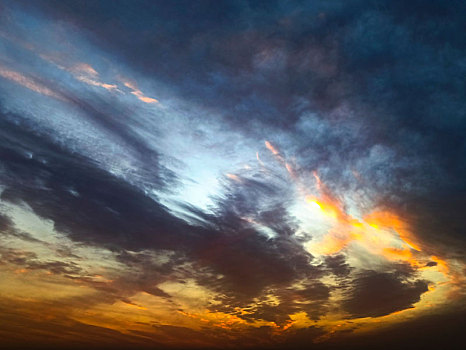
[343,271,428,318]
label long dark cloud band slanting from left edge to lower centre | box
[0,114,332,314]
